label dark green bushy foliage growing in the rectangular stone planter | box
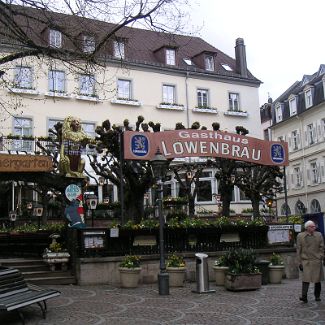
[225,248,259,274]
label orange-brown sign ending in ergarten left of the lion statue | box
[0,154,53,173]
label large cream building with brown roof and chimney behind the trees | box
[0,6,263,212]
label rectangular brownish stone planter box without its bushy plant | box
[225,273,262,291]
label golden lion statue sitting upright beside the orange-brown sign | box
[59,116,90,178]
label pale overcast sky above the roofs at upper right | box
[190,0,325,105]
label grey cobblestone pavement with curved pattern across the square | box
[0,280,325,325]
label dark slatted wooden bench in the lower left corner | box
[0,266,61,324]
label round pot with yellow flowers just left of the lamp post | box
[119,255,141,288]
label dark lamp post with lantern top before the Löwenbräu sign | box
[150,148,169,295]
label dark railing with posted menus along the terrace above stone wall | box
[75,226,268,257]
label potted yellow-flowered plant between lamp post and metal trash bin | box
[166,254,186,287]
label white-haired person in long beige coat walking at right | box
[297,220,324,303]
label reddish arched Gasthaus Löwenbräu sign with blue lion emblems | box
[124,129,288,166]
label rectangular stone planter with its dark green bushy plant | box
[225,248,262,291]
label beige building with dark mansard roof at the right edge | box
[271,64,325,215]
